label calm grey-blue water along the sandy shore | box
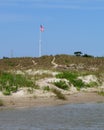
[0,103,104,130]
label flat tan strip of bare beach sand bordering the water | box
[0,92,104,110]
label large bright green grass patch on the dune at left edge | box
[0,72,38,95]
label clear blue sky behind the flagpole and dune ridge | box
[0,0,104,58]
